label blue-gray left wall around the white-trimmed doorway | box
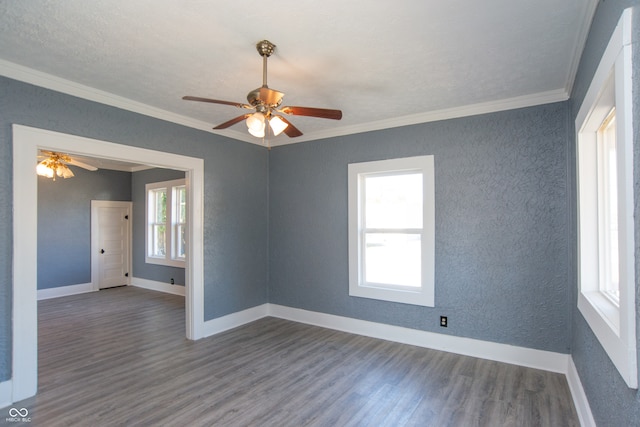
[0,77,269,381]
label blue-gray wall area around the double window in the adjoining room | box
[131,168,185,286]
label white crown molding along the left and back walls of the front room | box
[0,59,577,148]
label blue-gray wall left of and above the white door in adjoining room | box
[38,166,131,289]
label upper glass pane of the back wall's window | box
[364,173,422,228]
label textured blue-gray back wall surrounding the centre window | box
[269,103,569,353]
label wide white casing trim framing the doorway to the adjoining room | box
[11,125,204,402]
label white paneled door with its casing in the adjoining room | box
[91,200,132,289]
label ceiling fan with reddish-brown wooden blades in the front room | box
[182,40,342,138]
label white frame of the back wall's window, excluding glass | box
[348,156,435,307]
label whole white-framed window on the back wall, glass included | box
[348,156,435,307]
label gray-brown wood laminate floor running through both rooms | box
[0,288,579,427]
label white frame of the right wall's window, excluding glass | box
[575,9,638,388]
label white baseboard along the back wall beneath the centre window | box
[268,304,570,374]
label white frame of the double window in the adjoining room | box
[145,179,189,268]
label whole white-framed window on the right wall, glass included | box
[576,11,638,388]
